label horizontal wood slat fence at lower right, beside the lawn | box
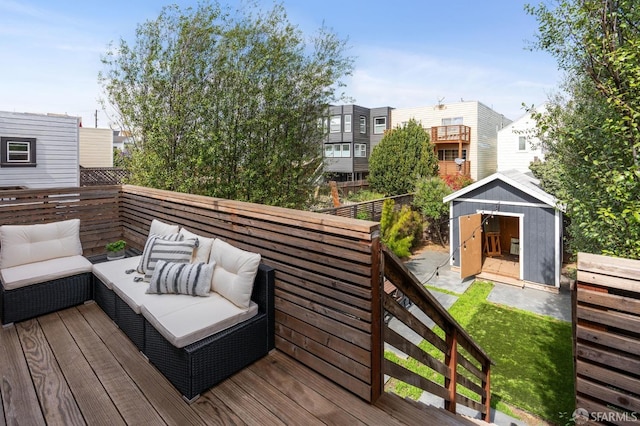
[573,253,640,424]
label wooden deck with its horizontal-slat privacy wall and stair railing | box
[0,185,491,424]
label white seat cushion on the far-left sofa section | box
[0,255,93,290]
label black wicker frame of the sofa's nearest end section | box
[144,265,275,401]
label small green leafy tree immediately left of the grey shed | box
[413,177,453,247]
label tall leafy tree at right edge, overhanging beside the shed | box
[527,0,640,258]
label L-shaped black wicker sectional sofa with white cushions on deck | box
[0,221,274,402]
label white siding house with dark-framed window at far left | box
[0,111,80,188]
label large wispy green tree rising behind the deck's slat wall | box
[100,3,352,207]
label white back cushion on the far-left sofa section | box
[0,219,82,269]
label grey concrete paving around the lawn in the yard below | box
[402,251,571,426]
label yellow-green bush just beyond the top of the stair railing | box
[380,199,423,257]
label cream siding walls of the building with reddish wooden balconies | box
[391,101,511,180]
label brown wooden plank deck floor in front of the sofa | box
[0,303,477,425]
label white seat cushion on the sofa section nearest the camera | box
[142,293,258,348]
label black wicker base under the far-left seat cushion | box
[0,272,93,324]
